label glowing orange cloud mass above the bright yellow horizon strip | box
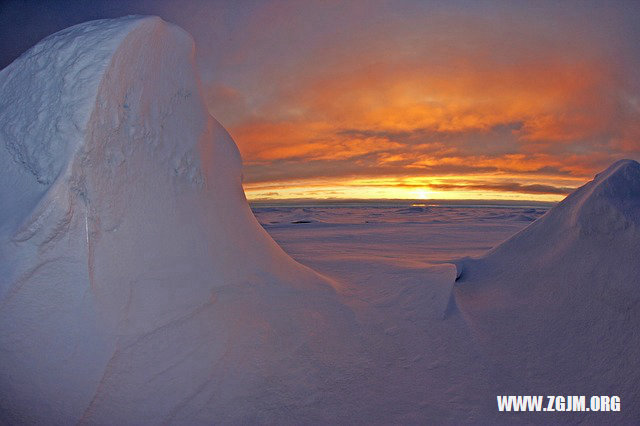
[201,2,640,199]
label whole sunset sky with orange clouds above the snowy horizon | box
[0,0,640,201]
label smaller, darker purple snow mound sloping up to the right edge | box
[454,160,640,419]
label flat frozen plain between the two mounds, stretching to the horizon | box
[252,202,548,275]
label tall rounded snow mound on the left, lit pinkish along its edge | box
[0,16,358,424]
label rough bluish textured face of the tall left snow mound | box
[0,17,145,185]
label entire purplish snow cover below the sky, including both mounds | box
[0,17,640,424]
